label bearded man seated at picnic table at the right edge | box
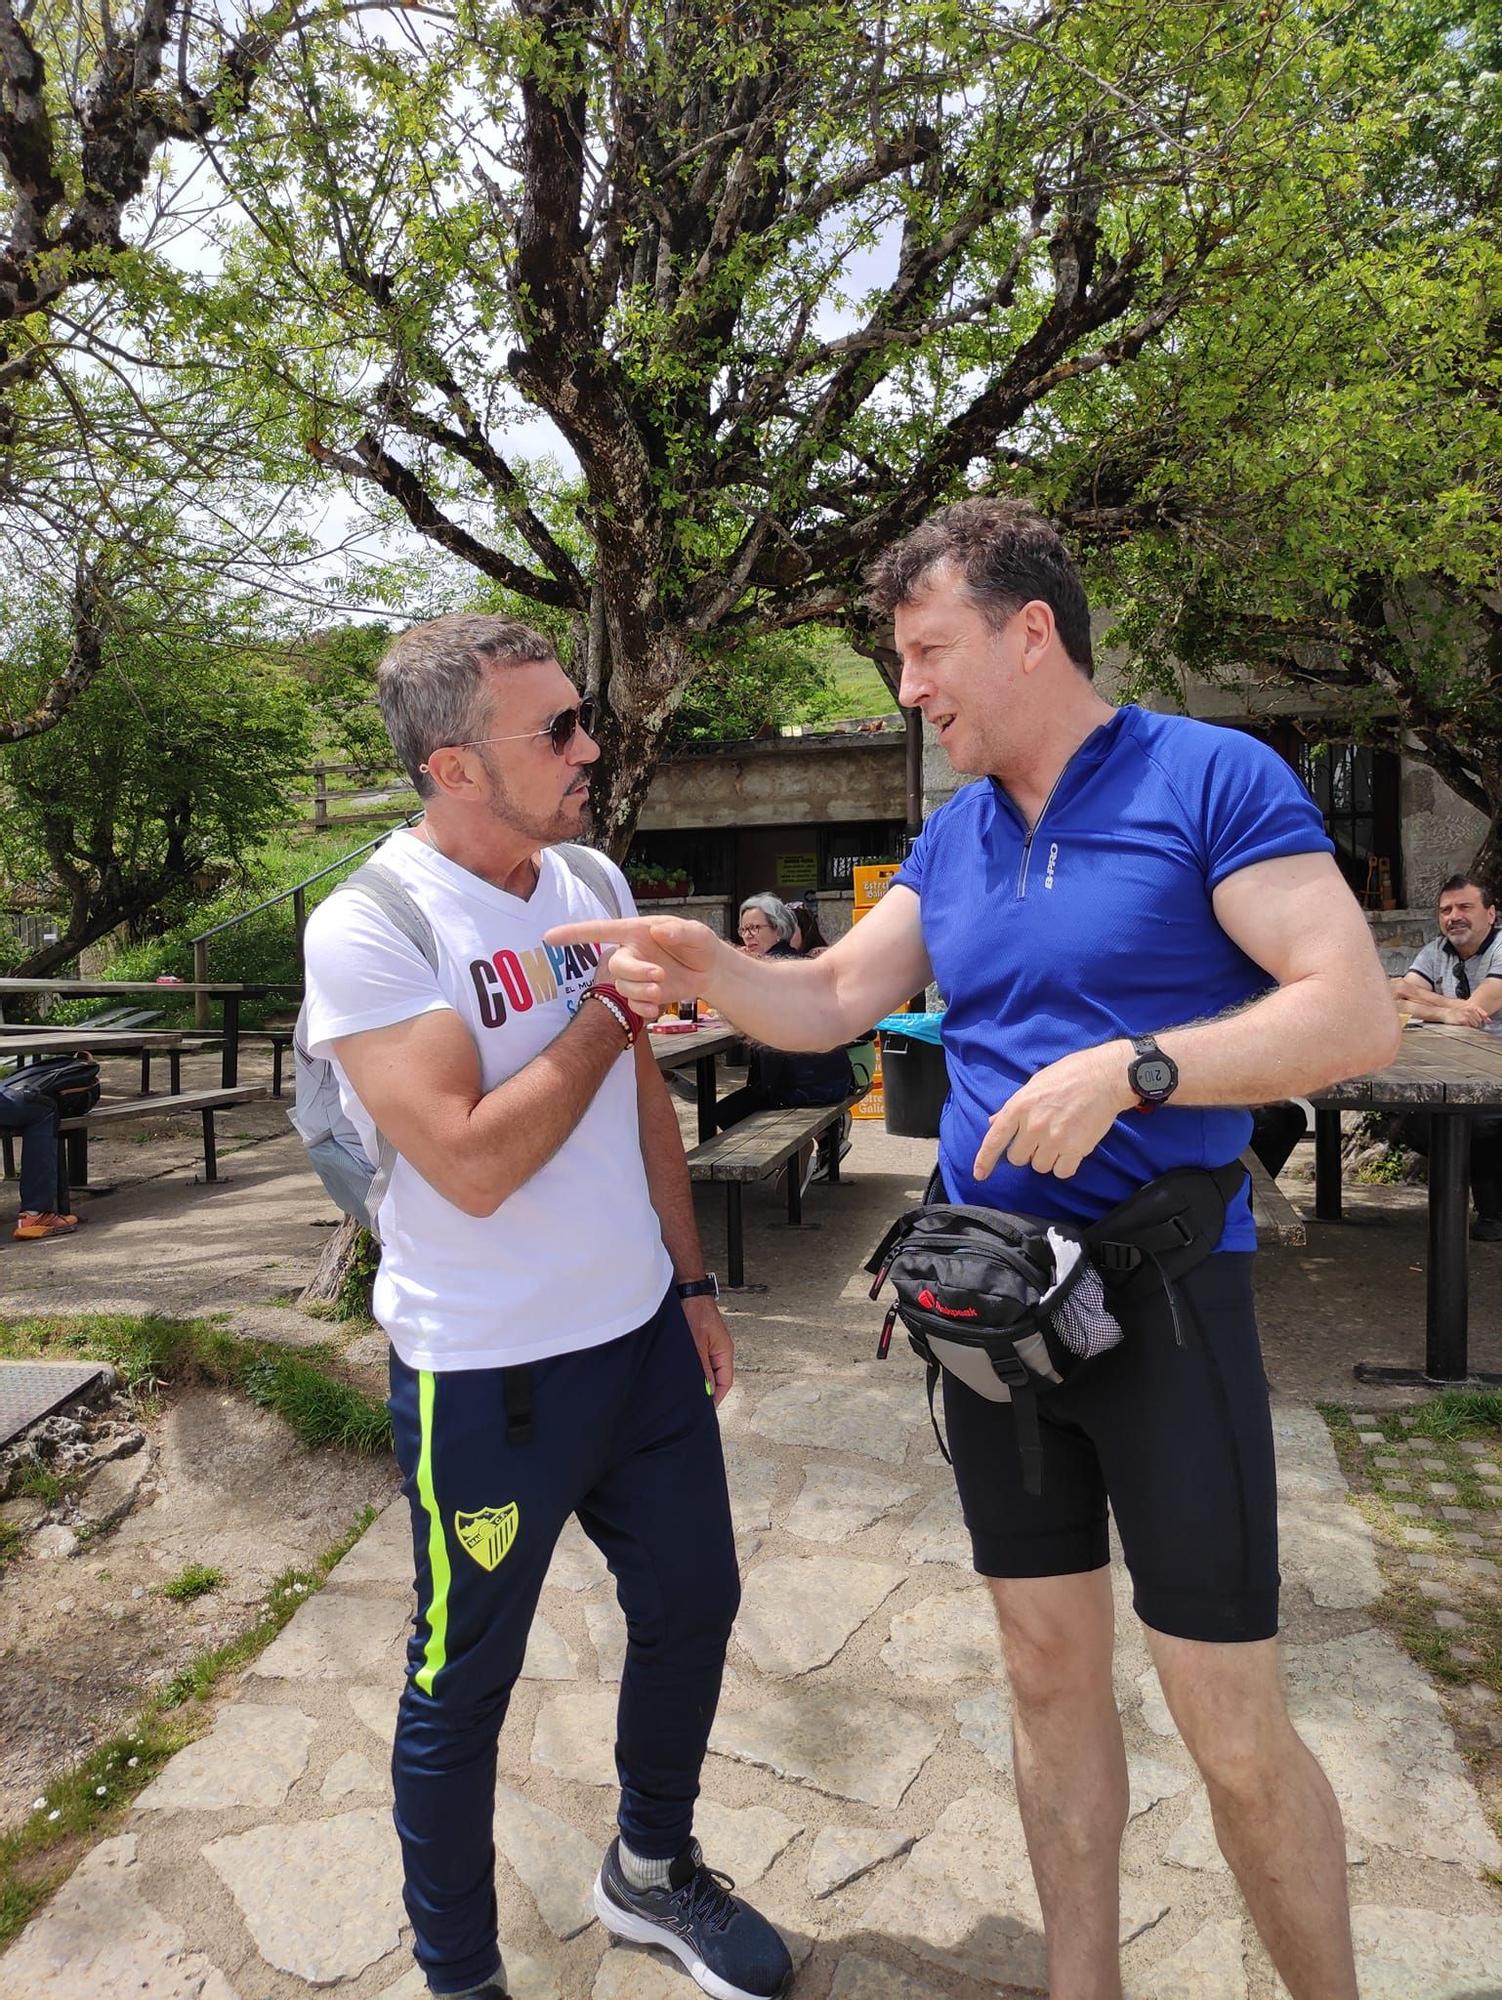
[1392,874,1502,1244]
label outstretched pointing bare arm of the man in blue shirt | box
[548,888,934,1048]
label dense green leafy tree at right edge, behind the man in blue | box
[1052,0,1502,878]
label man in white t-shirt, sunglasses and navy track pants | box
[308,616,792,2000]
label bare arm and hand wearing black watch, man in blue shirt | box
[976,854,1402,1178]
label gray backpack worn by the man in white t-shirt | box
[286,842,620,1240]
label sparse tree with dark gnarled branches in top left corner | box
[0,0,294,742]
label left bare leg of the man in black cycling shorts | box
[990,1570,1126,2000]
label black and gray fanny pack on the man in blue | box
[866,1160,1246,1494]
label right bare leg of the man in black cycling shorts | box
[1148,1630,1356,2000]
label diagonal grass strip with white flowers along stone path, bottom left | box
[0,1506,376,1946]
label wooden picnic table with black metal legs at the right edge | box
[1310,1022,1502,1386]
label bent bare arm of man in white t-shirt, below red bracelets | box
[334,1002,624,1216]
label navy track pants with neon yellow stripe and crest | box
[390,1292,740,1994]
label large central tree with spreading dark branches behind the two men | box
[214,0,1346,852]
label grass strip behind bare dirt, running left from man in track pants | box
[0,1314,392,1464]
